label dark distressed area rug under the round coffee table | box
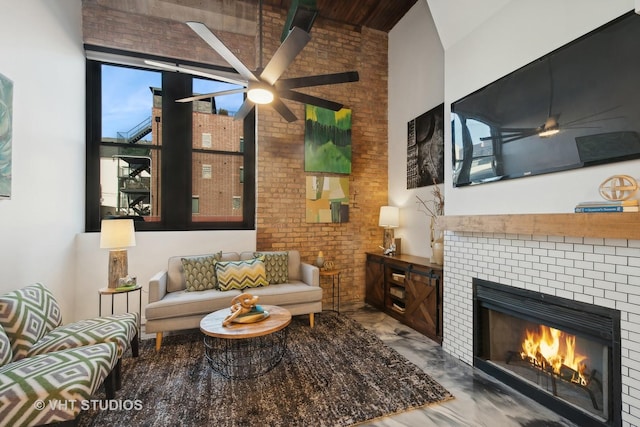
[79,312,452,427]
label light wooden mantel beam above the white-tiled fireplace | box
[438,212,640,240]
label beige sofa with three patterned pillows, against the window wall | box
[145,250,322,350]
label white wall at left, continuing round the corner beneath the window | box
[0,0,256,322]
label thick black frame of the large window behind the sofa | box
[85,51,256,232]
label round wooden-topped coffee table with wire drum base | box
[200,305,291,378]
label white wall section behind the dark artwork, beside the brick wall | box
[389,1,446,257]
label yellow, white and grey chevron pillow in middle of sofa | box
[215,257,269,291]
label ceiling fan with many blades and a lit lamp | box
[145,4,359,122]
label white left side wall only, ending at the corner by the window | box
[0,0,85,319]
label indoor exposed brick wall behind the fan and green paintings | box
[83,0,388,304]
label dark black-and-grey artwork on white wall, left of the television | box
[407,104,444,189]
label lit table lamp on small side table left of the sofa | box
[100,219,136,288]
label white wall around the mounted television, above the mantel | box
[445,0,640,215]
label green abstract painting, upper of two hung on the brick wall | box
[304,105,351,174]
